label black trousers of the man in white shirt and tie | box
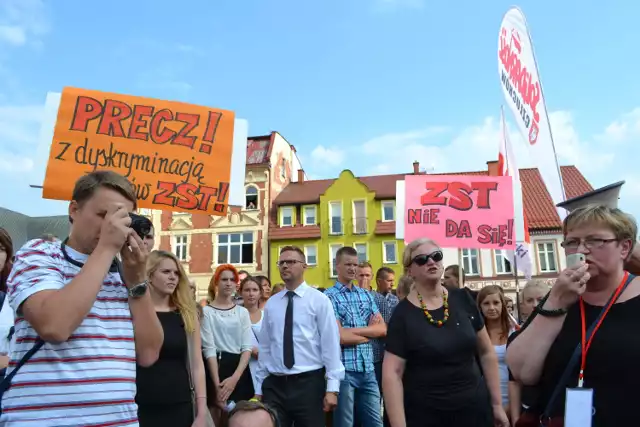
[262,369,327,427]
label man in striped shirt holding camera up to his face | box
[0,171,163,427]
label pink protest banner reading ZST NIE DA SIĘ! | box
[404,175,516,249]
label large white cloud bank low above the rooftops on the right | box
[303,108,640,219]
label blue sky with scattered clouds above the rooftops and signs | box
[0,0,640,219]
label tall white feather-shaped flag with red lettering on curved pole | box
[498,7,566,219]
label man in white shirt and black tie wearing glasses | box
[256,246,344,427]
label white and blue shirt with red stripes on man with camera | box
[0,240,138,427]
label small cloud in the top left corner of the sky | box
[0,0,50,46]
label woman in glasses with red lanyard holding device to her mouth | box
[507,205,640,427]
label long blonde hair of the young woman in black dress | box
[147,251,198,333]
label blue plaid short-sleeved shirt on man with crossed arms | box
[324,282,380,372]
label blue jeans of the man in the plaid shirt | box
[333,371,382,427]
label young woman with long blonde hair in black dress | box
[136,251,210,427]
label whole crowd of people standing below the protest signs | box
[0,171,640,427]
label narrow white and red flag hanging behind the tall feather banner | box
[498,109,533,280]
